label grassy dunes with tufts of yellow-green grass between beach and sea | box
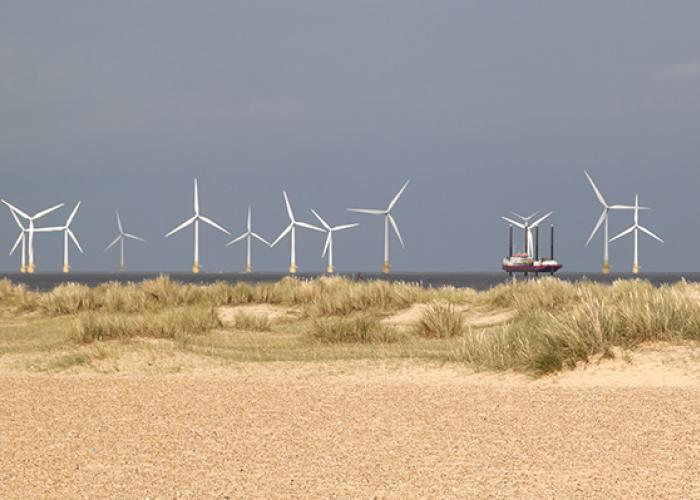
[0,277,700,374]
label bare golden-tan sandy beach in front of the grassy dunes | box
[0,347,700,498]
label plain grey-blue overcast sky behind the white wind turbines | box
[0,0,700,272]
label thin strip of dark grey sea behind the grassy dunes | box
[0,272,700,291]
